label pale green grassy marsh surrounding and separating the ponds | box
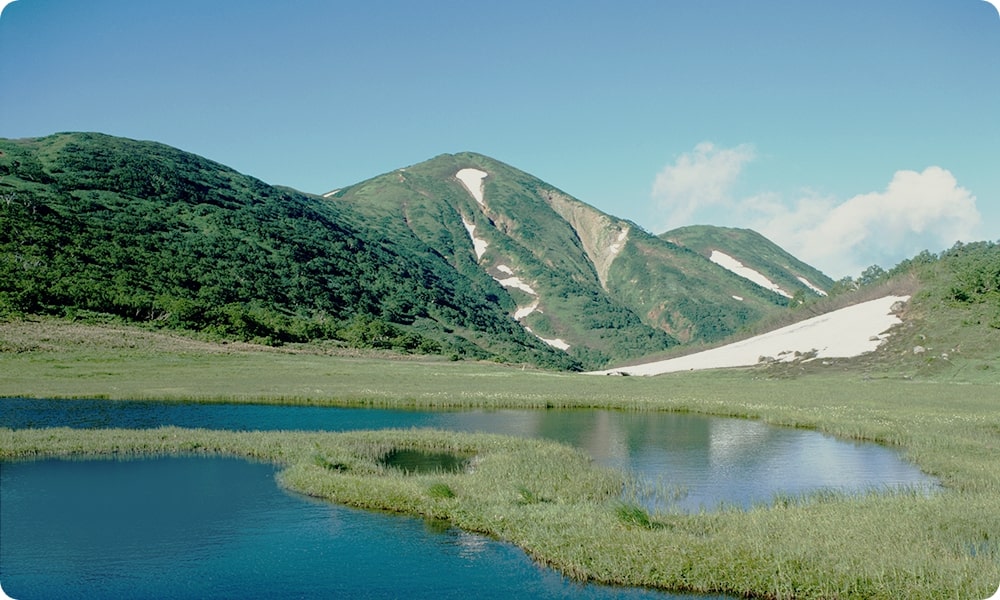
[0,322,1000,599]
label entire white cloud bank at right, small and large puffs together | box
[652,142,982,278]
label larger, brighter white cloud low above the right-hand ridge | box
[743,167,981,278]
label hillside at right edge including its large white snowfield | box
[601,242,1000,383]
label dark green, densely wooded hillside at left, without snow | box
[0,134,573,368]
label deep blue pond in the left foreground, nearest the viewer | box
[0,458,719,600]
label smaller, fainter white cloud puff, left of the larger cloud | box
[652,142,754,231]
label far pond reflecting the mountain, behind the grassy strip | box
[0,398,936,511]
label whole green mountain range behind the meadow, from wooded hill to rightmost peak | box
[0,133,844,369]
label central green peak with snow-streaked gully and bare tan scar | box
[329,153,820,365]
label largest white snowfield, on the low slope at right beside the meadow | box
[592,296,910,375]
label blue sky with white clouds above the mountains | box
[0,0,1000,278]
